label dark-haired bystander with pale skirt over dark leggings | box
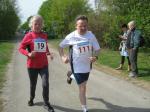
[116,24,131,71]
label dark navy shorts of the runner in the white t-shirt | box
[74,72,90,85]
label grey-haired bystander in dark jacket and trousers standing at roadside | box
[127,21,141,77]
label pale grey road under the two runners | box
[2,43,150,112]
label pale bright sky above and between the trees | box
[17,0,94,23]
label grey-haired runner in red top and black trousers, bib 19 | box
[19,15,54,112]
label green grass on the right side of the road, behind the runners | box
[49,39,150,82]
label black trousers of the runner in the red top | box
[28,67,49,103]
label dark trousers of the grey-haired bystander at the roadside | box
[129,49,138,75]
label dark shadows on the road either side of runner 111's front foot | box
[54,98,150,112]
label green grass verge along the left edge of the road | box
[0,42,14,88]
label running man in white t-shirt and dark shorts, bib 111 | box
[59,15,100,112]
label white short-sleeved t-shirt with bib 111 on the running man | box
[59,31,100,73]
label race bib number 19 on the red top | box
[34,38,46,52]
